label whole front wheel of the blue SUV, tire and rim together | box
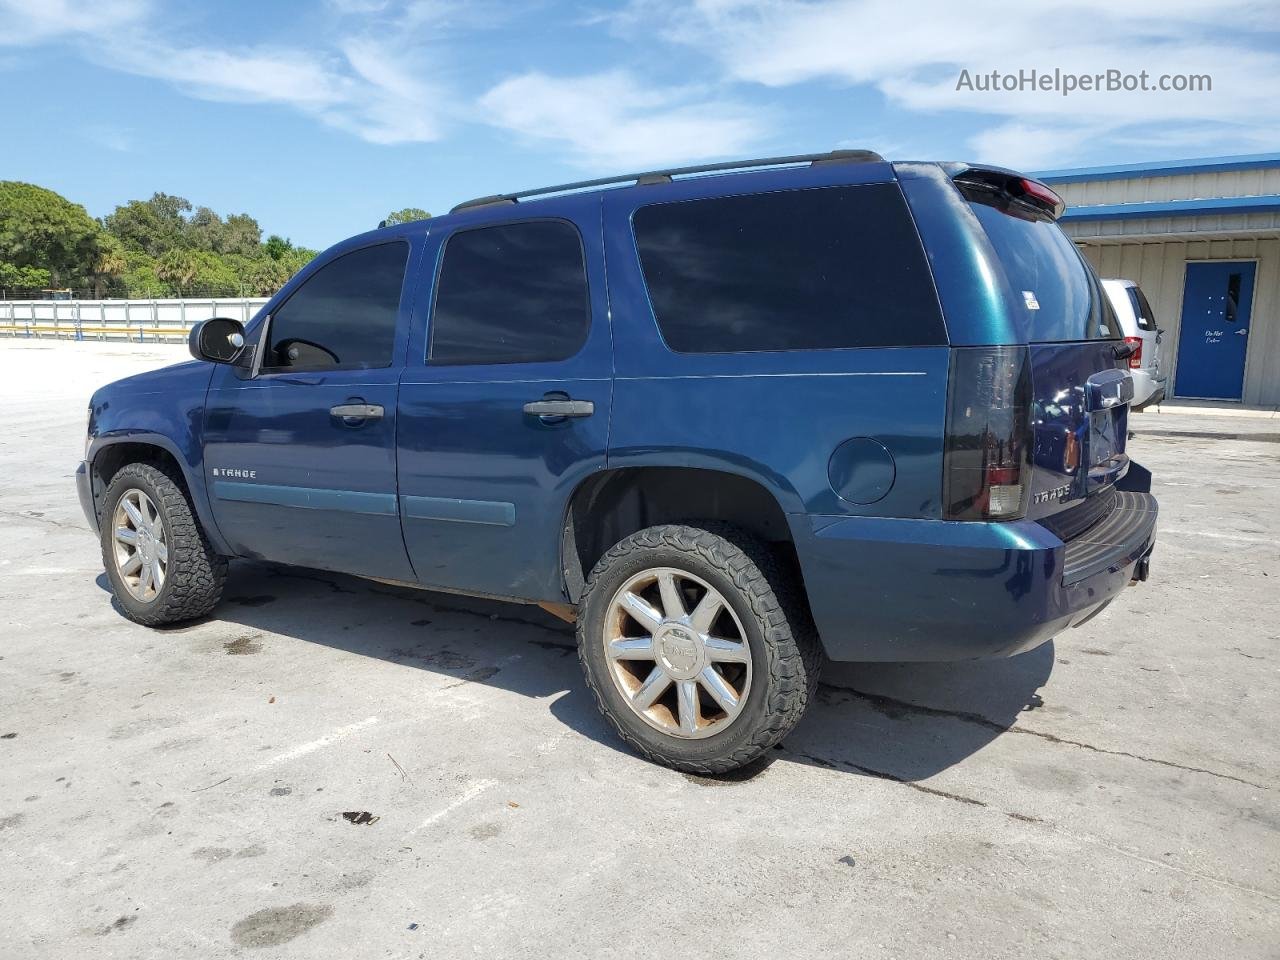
[101,463,227,626]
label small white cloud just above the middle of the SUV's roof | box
[480,70,764,169]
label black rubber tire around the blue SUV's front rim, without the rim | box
[99,463,227,627]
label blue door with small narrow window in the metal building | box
[1174,261,1257,401]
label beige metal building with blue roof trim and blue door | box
[1037,154,1280,406]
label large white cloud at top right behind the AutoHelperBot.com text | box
[613,0,1280,165]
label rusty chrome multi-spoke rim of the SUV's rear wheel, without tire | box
[603,567,751,740]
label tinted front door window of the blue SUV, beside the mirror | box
[262,242,408,370]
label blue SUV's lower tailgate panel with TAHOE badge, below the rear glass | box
[1027,340,1133,518]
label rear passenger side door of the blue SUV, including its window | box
[399,197,613,600]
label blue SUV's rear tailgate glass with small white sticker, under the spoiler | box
[969,202,1120,343]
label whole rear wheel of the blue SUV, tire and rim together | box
[577,525,819,773]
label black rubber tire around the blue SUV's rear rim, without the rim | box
[577,524,822,774]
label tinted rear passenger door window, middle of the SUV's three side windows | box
[430,220,590,364]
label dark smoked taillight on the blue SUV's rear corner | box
[942,347,1032,520]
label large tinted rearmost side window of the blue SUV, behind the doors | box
[632,183,946,353]
